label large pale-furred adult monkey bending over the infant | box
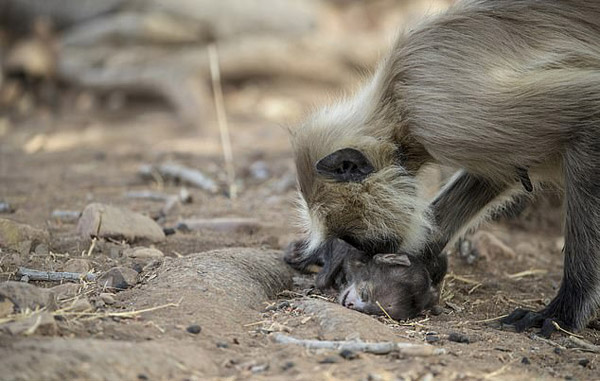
[291,0,600,336]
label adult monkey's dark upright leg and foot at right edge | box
[503,147,600,337]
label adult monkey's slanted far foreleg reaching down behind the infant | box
[421,170,518,284]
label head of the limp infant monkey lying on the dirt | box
[338,254,438,320]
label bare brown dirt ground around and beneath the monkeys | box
[0,1,600,380]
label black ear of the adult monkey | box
[316,148,375,182]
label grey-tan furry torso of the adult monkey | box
[384,0,600,175]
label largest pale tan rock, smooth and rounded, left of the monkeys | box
[77,203,165,242]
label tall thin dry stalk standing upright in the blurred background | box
[208,44,237,200]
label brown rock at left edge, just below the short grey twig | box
[0,281,56,312]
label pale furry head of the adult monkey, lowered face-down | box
[291,104,430,254]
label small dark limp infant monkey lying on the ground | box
[284,239,446,320]
